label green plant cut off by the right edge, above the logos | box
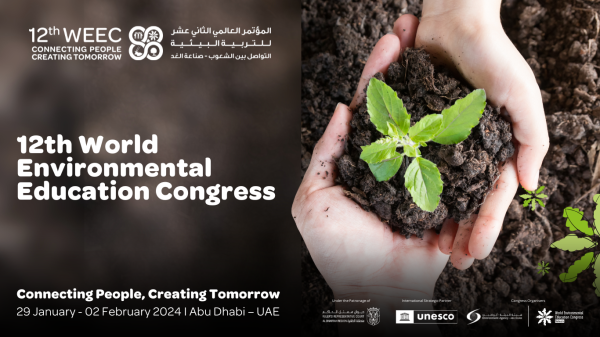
[550,194,600,297]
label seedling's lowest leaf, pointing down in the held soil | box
[404,157,443,212]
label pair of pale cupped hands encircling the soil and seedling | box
[292,6,549,298]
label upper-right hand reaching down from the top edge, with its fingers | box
[410,0,549,269]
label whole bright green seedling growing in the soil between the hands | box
[360,78,486,212]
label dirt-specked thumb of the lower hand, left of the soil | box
[298,103,352,196]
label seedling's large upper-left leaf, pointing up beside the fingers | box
[367,78,410,136]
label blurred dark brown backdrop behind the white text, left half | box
[0,0,301,330]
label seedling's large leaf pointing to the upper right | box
[433,89,486,145]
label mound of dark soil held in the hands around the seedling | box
[338,48,514,237]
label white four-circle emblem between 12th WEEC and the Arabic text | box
[129,26,163,61]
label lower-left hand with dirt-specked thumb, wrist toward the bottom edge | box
[292,15,448,308]
